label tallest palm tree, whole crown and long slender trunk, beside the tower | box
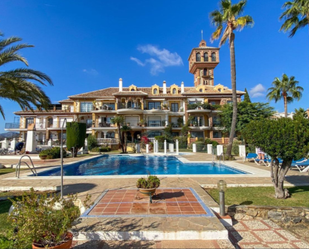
[210,0,253,157]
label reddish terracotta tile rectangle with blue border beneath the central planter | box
[89,189,207,215]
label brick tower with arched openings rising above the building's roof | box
[188,40,219,87]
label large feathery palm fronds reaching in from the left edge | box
[0,32,53,119]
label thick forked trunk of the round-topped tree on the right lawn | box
[271,159,292,199]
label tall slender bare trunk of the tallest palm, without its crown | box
[226,33,237,157]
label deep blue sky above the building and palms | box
[0,0,309,132]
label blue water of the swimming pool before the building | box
[38,155,247,176]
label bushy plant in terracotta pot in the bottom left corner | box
[8,188,90,248]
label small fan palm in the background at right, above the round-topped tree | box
[266,74,304,117]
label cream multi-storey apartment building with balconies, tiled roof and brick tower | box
[5,40,244,144]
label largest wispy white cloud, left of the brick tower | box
[130,44,183,75]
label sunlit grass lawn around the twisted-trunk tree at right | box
[205,186,309,207]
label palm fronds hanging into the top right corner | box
[280,0,309,37]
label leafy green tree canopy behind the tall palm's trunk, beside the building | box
[220,101,274,134]
